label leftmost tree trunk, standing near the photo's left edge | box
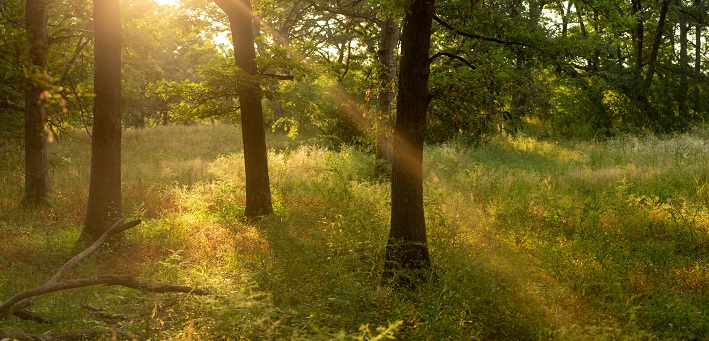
[24,0,49,205]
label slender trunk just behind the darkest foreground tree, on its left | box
[375,18,399,176]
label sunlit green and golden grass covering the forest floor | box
[0,125,709,340]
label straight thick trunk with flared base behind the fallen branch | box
[80,0,123,243]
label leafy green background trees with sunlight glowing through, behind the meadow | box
[0,0,707,149]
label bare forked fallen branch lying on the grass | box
[0,220,211,322]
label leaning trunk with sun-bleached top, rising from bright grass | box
[215,0,273,217]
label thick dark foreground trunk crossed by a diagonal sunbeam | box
[384,0,435,285]
